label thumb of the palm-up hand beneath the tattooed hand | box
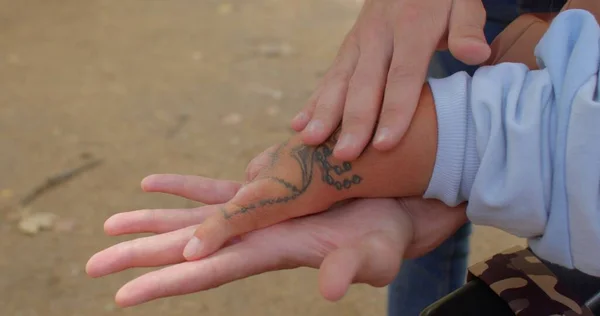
[319,231,410,301]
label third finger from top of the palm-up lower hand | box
[86,226,195,277]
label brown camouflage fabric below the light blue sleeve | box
[468,247,594,316]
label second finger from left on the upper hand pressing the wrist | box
[302,35,359,145]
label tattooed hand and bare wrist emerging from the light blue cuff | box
[184,85,437,260]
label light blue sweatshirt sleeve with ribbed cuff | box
[425,10,600,276]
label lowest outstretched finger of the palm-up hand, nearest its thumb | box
[116,243,280,307]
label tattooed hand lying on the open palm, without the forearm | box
[182,132,380,260]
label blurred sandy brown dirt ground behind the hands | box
[0,0,521,316]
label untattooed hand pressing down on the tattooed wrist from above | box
[292,0,490,161]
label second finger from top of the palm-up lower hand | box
[104,205,220,236]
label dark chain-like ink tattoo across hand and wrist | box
[221,129,363,219]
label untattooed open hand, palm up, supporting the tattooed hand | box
[86,175,466,306]
